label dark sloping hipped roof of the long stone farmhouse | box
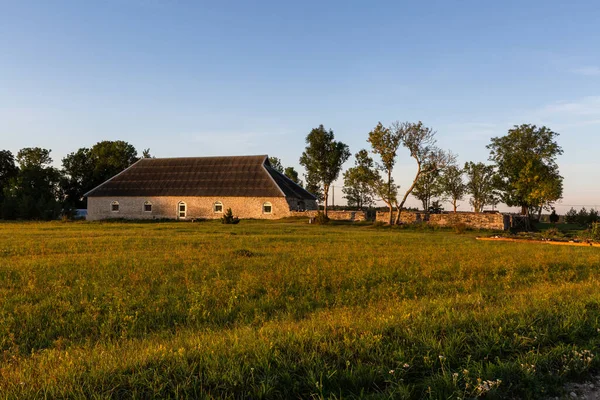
[85,155,315,200]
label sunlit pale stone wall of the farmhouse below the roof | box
[87,196,316,221]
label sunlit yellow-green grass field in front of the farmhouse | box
[0,221,600,399]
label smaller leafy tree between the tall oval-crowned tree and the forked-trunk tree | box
[342,149,379,209]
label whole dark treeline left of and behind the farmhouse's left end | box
[0,140,150,220]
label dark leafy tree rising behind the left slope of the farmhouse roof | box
[60,140,139,208]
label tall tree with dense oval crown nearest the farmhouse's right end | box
[300,125,350,216]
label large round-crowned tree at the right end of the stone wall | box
[487,124,563,216]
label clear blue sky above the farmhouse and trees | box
[0,0,600,210]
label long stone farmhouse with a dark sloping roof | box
[85,155,317,220]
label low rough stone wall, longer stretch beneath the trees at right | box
[376,211,510,230]
